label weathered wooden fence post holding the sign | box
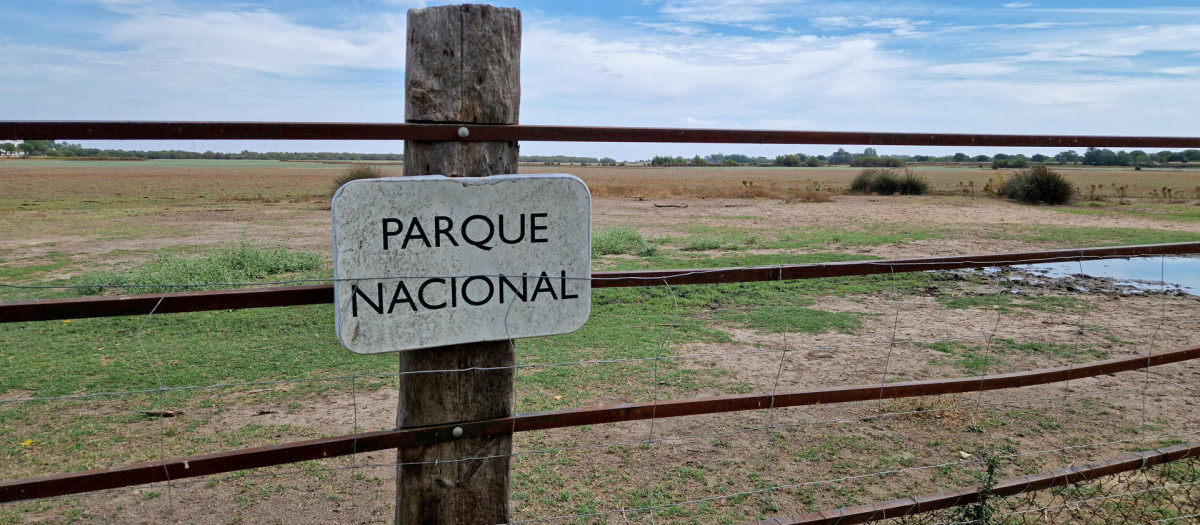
[396,5,521,524]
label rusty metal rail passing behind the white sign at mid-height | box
[0,242,1200,322]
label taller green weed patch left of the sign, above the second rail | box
[74,239,322,295]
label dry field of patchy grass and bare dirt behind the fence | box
[0,161,1200,524]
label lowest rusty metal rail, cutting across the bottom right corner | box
[743,441,1200,525]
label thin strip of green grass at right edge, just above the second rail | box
[984,225,1200,247]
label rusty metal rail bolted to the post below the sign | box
[0,346,1200,502]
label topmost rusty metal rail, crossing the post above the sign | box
[7,121,1200,147]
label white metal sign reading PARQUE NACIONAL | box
[332,175,592,354]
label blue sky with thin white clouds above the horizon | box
[0,0,1200,161]
